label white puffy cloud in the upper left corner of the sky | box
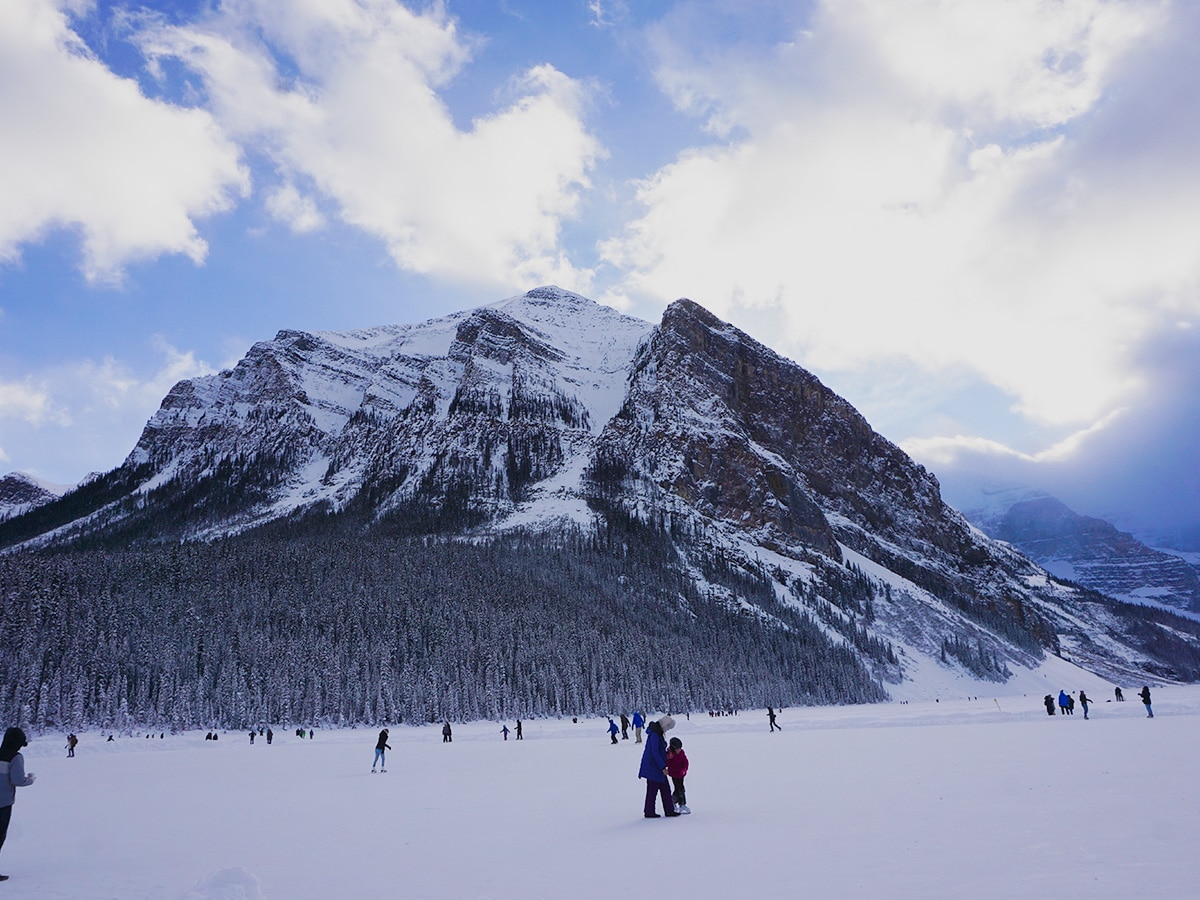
[0,0,248,281]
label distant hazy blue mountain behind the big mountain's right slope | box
[964,488,1200,612]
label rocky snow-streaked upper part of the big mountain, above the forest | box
[0,288,1200,684]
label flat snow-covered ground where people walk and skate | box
[0,685,1200,900]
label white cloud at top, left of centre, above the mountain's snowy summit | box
[142,0,601,289]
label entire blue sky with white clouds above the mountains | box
[0,0,1200,550]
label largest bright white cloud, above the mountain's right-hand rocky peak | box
[602,0,1200,431]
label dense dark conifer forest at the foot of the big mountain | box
[0,520,884,728]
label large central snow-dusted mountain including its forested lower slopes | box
[0,288,1200,724]
